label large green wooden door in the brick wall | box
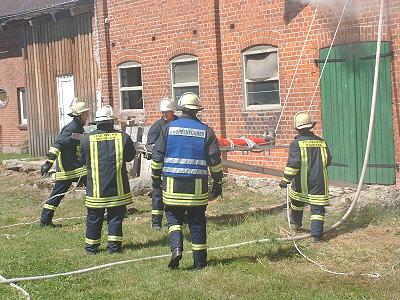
[320,42,395,184]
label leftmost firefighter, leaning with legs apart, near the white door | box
[40,102,89,227]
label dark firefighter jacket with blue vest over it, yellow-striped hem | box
[152,114,222,206]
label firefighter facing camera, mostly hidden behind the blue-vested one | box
[146,98,178,230]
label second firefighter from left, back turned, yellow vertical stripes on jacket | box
[81,106,136,254]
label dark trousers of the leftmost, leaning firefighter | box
[40,176,86,224]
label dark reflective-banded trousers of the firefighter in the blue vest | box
[165,205,207,269]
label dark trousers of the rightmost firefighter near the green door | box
[290,199,325,237]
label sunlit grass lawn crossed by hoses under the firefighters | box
[0,170,400,299]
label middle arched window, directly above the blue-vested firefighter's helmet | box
[171,55,200,103]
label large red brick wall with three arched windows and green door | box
[96,0,400,183]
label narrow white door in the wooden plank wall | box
[57,75,75,130]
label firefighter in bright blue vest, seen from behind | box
[152,92,222,270]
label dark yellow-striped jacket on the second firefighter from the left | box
[81,123,136,208]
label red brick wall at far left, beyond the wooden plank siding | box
[0,28,27,152]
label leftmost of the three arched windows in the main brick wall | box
[118,61,144,109]
